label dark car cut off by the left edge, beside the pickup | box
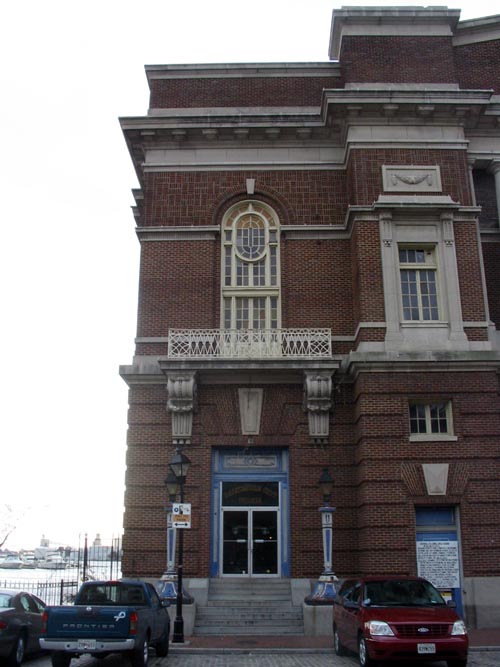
[0,588,46,667]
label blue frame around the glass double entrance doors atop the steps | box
[210,447,290,577]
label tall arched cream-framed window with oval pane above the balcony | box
[222,201,281,329]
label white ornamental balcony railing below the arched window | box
[168,329,332,360]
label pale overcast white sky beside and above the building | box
[0,0,494,548]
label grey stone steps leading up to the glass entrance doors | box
[194,578,304,637]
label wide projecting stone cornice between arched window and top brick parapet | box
[120,84,498,180]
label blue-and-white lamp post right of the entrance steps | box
[304,468,338,605]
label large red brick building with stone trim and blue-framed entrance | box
[120,7,500,626]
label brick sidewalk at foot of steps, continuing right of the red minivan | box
[170,628,500,653]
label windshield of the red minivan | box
[364,579,446,607]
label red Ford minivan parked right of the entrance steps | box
[333,576,469,667]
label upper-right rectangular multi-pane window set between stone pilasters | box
[399,248,439,322]
